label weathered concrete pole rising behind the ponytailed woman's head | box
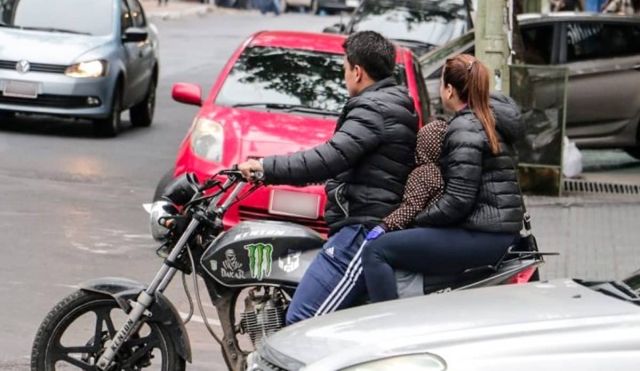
[475,0,509,95]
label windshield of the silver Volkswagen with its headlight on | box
[0,0,114,36]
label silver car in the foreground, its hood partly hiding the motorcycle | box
[247,271,640,371]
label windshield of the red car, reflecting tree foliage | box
[215,47,406,113]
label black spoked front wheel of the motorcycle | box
[31,290,186,371]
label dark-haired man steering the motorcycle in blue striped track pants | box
[238,31,418,325]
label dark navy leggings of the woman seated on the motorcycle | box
[362,228,519,303]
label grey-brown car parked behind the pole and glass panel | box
[420,12,640,158]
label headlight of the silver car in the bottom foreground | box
[341,353,447,371]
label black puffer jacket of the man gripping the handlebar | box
[263,77,418,235]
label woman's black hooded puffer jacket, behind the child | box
[414,93,524,233]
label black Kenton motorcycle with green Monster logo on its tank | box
[31,167,555,371]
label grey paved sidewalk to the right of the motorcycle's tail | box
[527,197,640,279]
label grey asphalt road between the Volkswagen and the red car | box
[0,13,344,371]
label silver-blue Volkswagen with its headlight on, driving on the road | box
[0,0,159,137]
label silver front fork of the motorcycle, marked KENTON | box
[96,219,199,371]
